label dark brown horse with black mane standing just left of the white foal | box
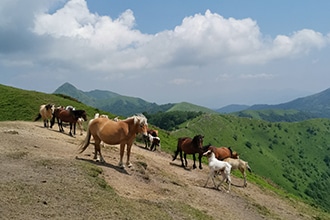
[172,134,204,169]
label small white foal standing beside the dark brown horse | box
[203,150,231,192]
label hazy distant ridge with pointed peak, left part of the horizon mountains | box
[54,83,217,116]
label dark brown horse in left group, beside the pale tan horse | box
[50,108,87,136]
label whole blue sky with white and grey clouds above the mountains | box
[0,0,330,109]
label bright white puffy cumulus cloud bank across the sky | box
[28,0,326,74]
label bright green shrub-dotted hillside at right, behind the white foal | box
[164,114,330,211]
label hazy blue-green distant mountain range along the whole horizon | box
[54,83,330,121]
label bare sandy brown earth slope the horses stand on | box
[0,121,322,220]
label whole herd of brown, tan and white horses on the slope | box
[35,104,251,191]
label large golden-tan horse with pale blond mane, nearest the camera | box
[80,114,148,167]
